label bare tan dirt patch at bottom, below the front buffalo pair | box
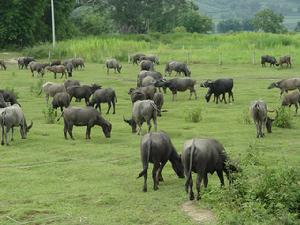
[181,201,216,225]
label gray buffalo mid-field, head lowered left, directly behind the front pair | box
[124,100,159,135]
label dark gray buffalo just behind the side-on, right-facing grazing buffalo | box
[90,88,117,114]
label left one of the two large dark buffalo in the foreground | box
[137,132,184,192]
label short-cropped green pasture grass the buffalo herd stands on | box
[0,51,300,225]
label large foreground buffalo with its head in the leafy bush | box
[181,139,238,200]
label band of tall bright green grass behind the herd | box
[24,32,300,63]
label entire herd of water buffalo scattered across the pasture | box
[0,54,300,200]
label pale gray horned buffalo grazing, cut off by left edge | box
[1,104,33,145]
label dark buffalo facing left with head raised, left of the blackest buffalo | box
[154,77,197,101]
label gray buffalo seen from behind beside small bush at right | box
[250,100,274,138]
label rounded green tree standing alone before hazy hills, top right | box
[253,9,286,33]
